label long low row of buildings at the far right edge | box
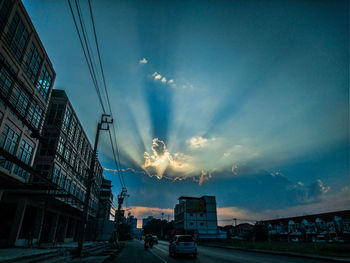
[261,210,350,242]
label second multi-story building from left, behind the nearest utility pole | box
[35,90,103,242]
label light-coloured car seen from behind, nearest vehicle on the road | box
[169,235,197,257]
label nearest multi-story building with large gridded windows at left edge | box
[0,0,55,246]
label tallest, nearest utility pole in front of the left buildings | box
[78,114,113,257]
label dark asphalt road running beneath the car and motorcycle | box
[111,240,336,263]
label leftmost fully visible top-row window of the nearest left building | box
[6,12,29,62]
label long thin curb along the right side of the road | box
[199,244,350,263]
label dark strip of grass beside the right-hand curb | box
[200,239,350,258]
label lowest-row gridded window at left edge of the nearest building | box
[0,124,19,170]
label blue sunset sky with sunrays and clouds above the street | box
[23,0,350,226]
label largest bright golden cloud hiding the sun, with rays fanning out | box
[142,138,191,179]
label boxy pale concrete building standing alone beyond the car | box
[174,195,219,239]
